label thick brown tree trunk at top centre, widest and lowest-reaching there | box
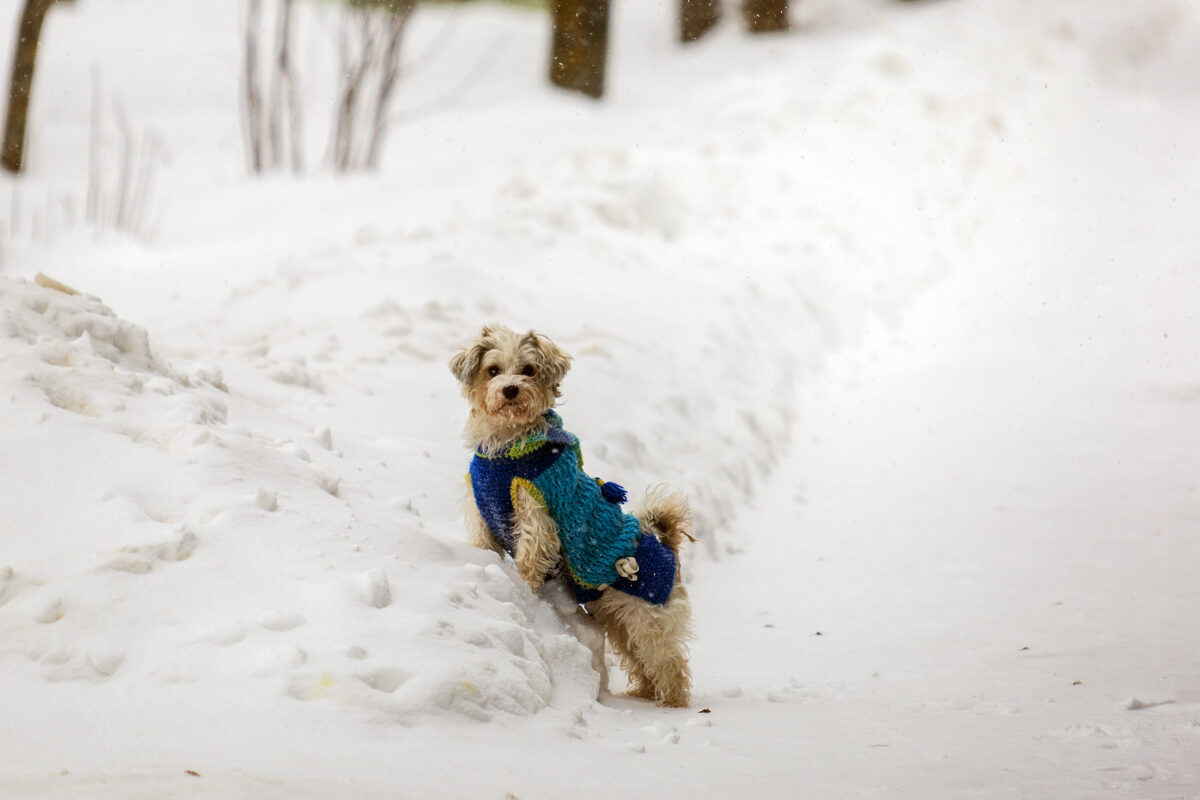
[550,0,608,97]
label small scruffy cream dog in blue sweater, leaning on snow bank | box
[450,325,695,706]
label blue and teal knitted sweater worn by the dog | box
[470,411,676,604]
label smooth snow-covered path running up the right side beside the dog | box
[696,67,1200,799]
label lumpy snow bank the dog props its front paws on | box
[0,278,595,720]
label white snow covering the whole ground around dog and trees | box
[0,0,1200,800]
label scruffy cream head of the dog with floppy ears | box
[450,325,571,446]
